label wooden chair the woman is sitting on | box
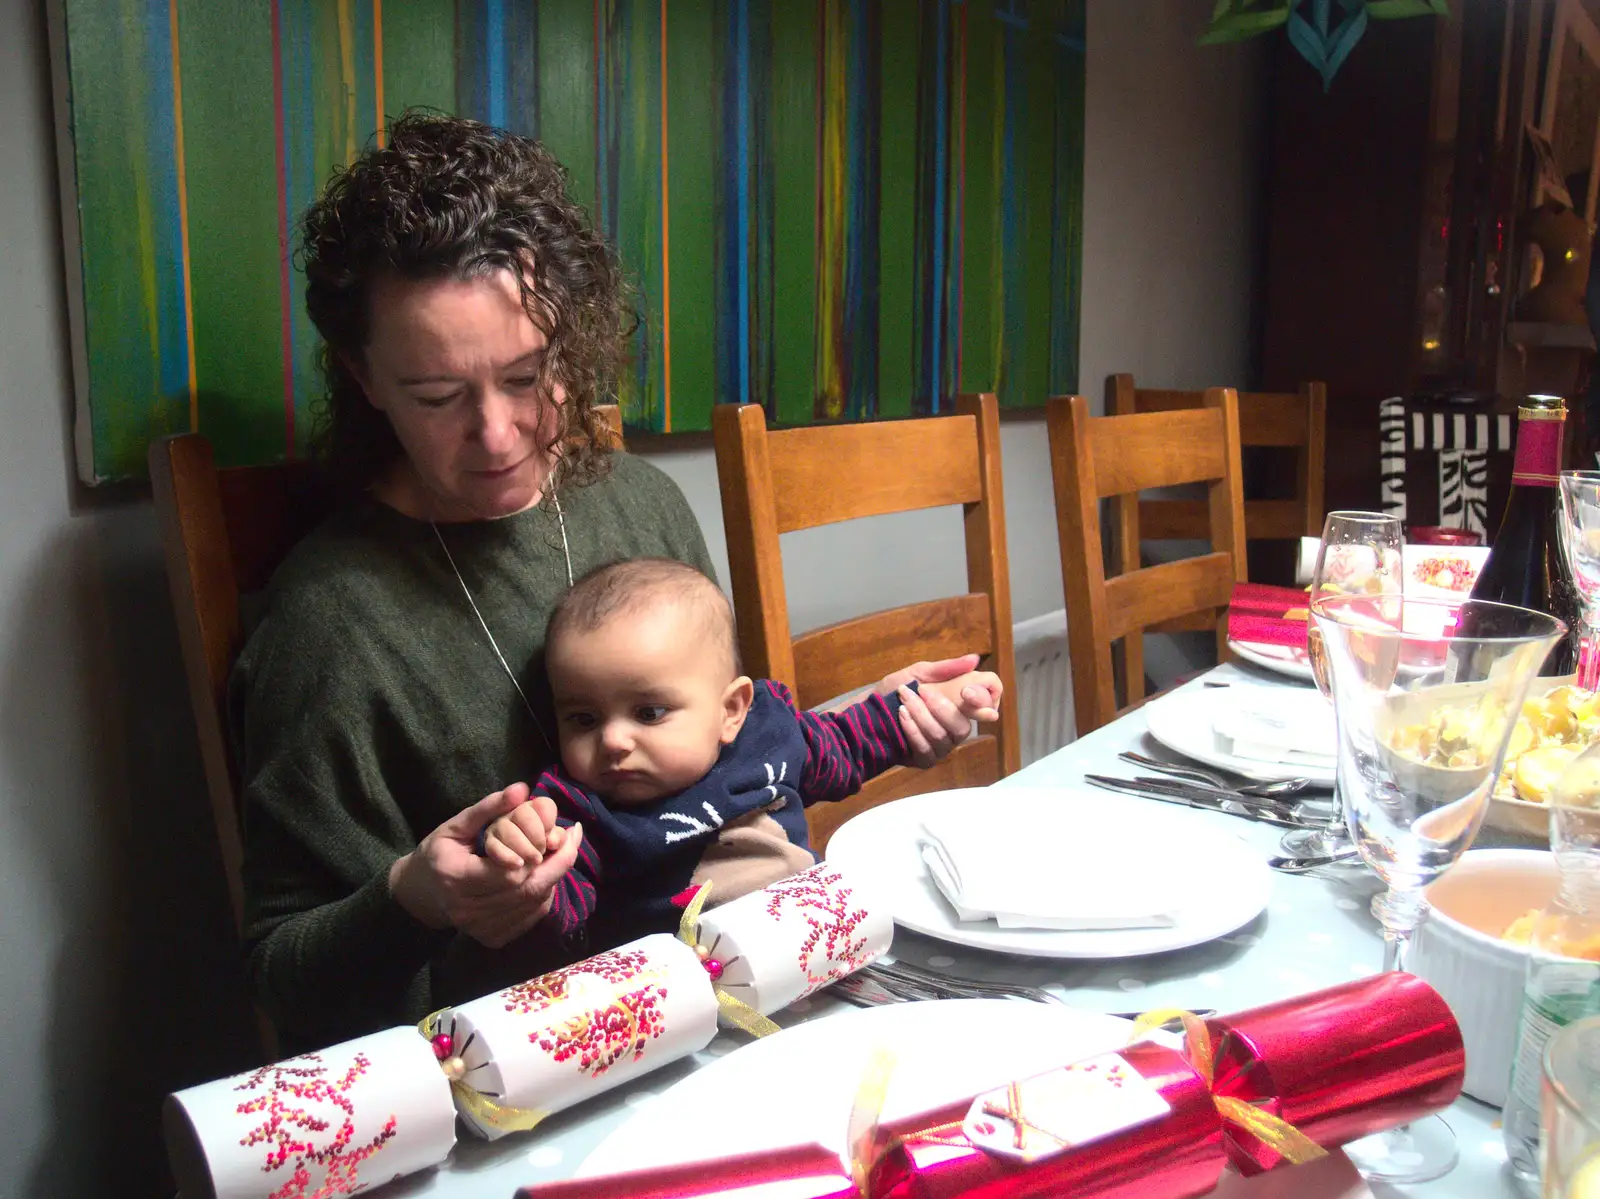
[149,405,622,928]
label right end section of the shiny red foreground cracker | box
[1206,972,1467,1175]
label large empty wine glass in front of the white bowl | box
[1310,594,1566,1183]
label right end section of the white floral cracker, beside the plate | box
[699,861,894,1015]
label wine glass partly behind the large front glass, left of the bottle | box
[1280,512,1405,858]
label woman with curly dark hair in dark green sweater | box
[229,114,973,1045]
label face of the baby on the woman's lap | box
[546,604,744,805]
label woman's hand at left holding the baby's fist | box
[389,783,582,949]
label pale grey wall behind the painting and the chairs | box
[0,0,1256,1196]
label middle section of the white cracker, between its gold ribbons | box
[443,933,717,1140]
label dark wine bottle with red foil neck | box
[1472,395,1579,676]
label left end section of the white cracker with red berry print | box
[163,1028,456,1199]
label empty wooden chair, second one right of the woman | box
[1045,387,1245,736]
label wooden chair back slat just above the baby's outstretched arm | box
[794,595,994,708]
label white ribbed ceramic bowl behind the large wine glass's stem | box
[1406,850,1555,1108]
